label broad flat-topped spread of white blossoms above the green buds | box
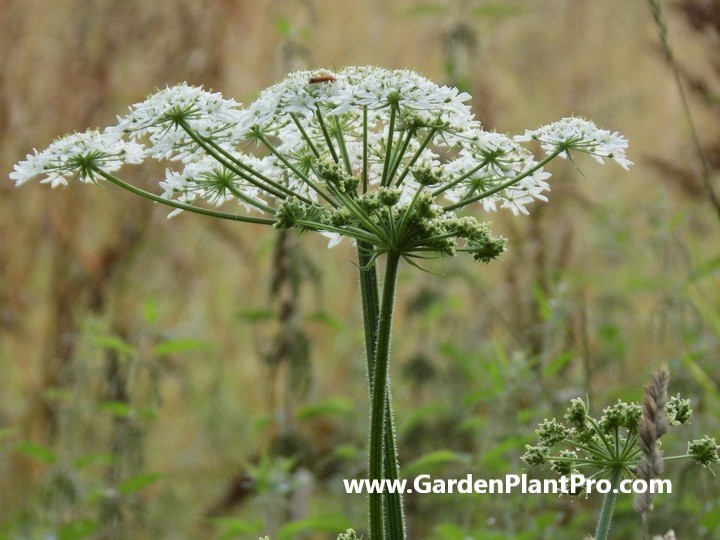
[10,67,632,229]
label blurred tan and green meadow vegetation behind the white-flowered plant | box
[0,0,720,540]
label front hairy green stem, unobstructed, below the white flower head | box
[369,251,404,540]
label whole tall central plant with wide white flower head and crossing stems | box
[10,67,632,539]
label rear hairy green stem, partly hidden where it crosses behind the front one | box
[358,242,405,539]
